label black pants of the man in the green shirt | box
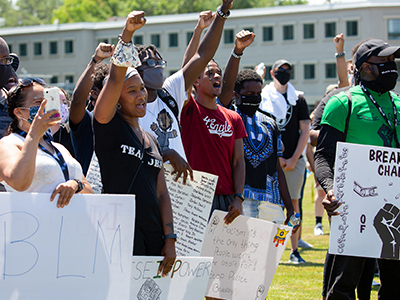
[327,255,400,300]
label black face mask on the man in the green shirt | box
[369,61,399,93]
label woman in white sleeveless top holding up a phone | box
[0,78,92,208]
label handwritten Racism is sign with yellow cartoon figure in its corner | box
[201,210,291,300]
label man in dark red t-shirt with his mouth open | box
[181,59,247,224]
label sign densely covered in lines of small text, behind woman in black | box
[164,164,218,256]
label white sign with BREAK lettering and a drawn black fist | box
[329,143,400,259]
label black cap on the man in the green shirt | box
[354,39,400,69]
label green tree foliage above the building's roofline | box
[0,0,307,27]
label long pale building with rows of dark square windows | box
[0,0,400,105]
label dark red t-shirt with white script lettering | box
[181,97,247,195]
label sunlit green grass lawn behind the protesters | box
[266,176,379,300]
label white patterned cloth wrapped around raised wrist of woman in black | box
[110,40,142,68]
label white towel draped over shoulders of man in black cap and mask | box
[260,82,304,119]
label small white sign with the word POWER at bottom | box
[130,256,213,300]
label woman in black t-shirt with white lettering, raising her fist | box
[93,11,176,276]
